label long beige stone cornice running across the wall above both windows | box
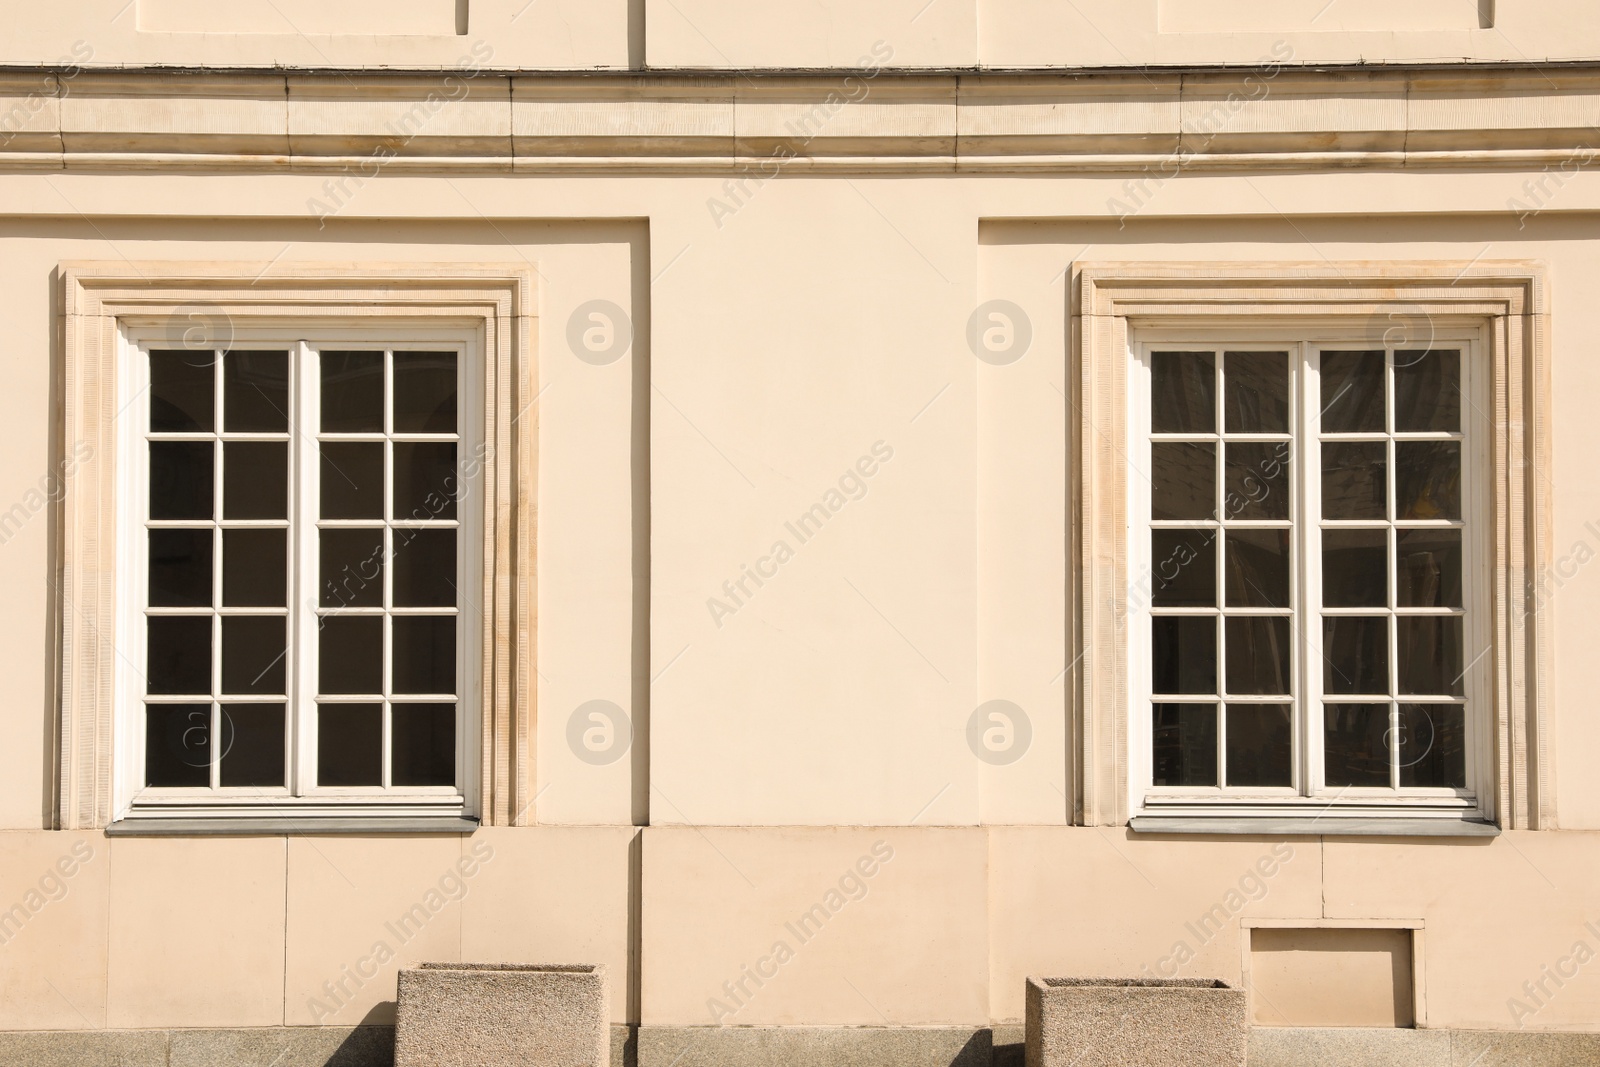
[0,67,1600,181]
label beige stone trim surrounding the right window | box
[1067,262,1555,829]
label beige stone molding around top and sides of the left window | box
[56,262,538,832]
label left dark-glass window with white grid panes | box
[123,338,483,814]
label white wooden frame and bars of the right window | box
[1126,329,1493,821]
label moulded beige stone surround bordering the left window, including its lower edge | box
[56,262,538,829]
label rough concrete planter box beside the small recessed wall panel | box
[1026,977,1250,1067]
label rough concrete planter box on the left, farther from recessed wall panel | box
[395,963,611,1067]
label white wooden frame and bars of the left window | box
[114,323,485,819]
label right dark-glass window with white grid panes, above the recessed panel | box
[1128,342,1486,814]
